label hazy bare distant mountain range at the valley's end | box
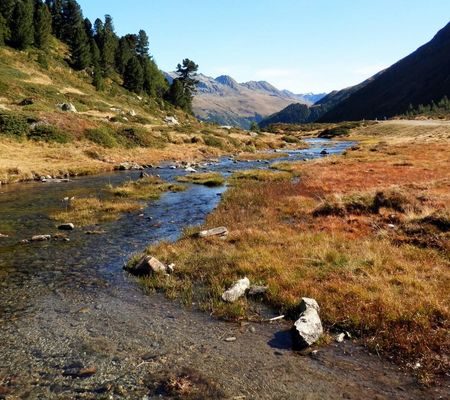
[166,72,325,128]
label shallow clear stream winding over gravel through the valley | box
[0,139,443,400]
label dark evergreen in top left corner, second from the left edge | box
[11,0,34,50]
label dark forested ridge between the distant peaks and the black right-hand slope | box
[259,72,381,128]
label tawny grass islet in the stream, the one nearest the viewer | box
[51,197,142,227]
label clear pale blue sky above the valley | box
[79,0,450,93]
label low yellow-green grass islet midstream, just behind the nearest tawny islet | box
[107,176,185,200]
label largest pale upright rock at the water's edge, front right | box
[292,298,323,349]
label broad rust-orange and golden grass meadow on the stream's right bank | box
[138,125,450,382]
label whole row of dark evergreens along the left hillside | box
[0,0,198,112]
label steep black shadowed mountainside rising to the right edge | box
[319,23,450,122]
